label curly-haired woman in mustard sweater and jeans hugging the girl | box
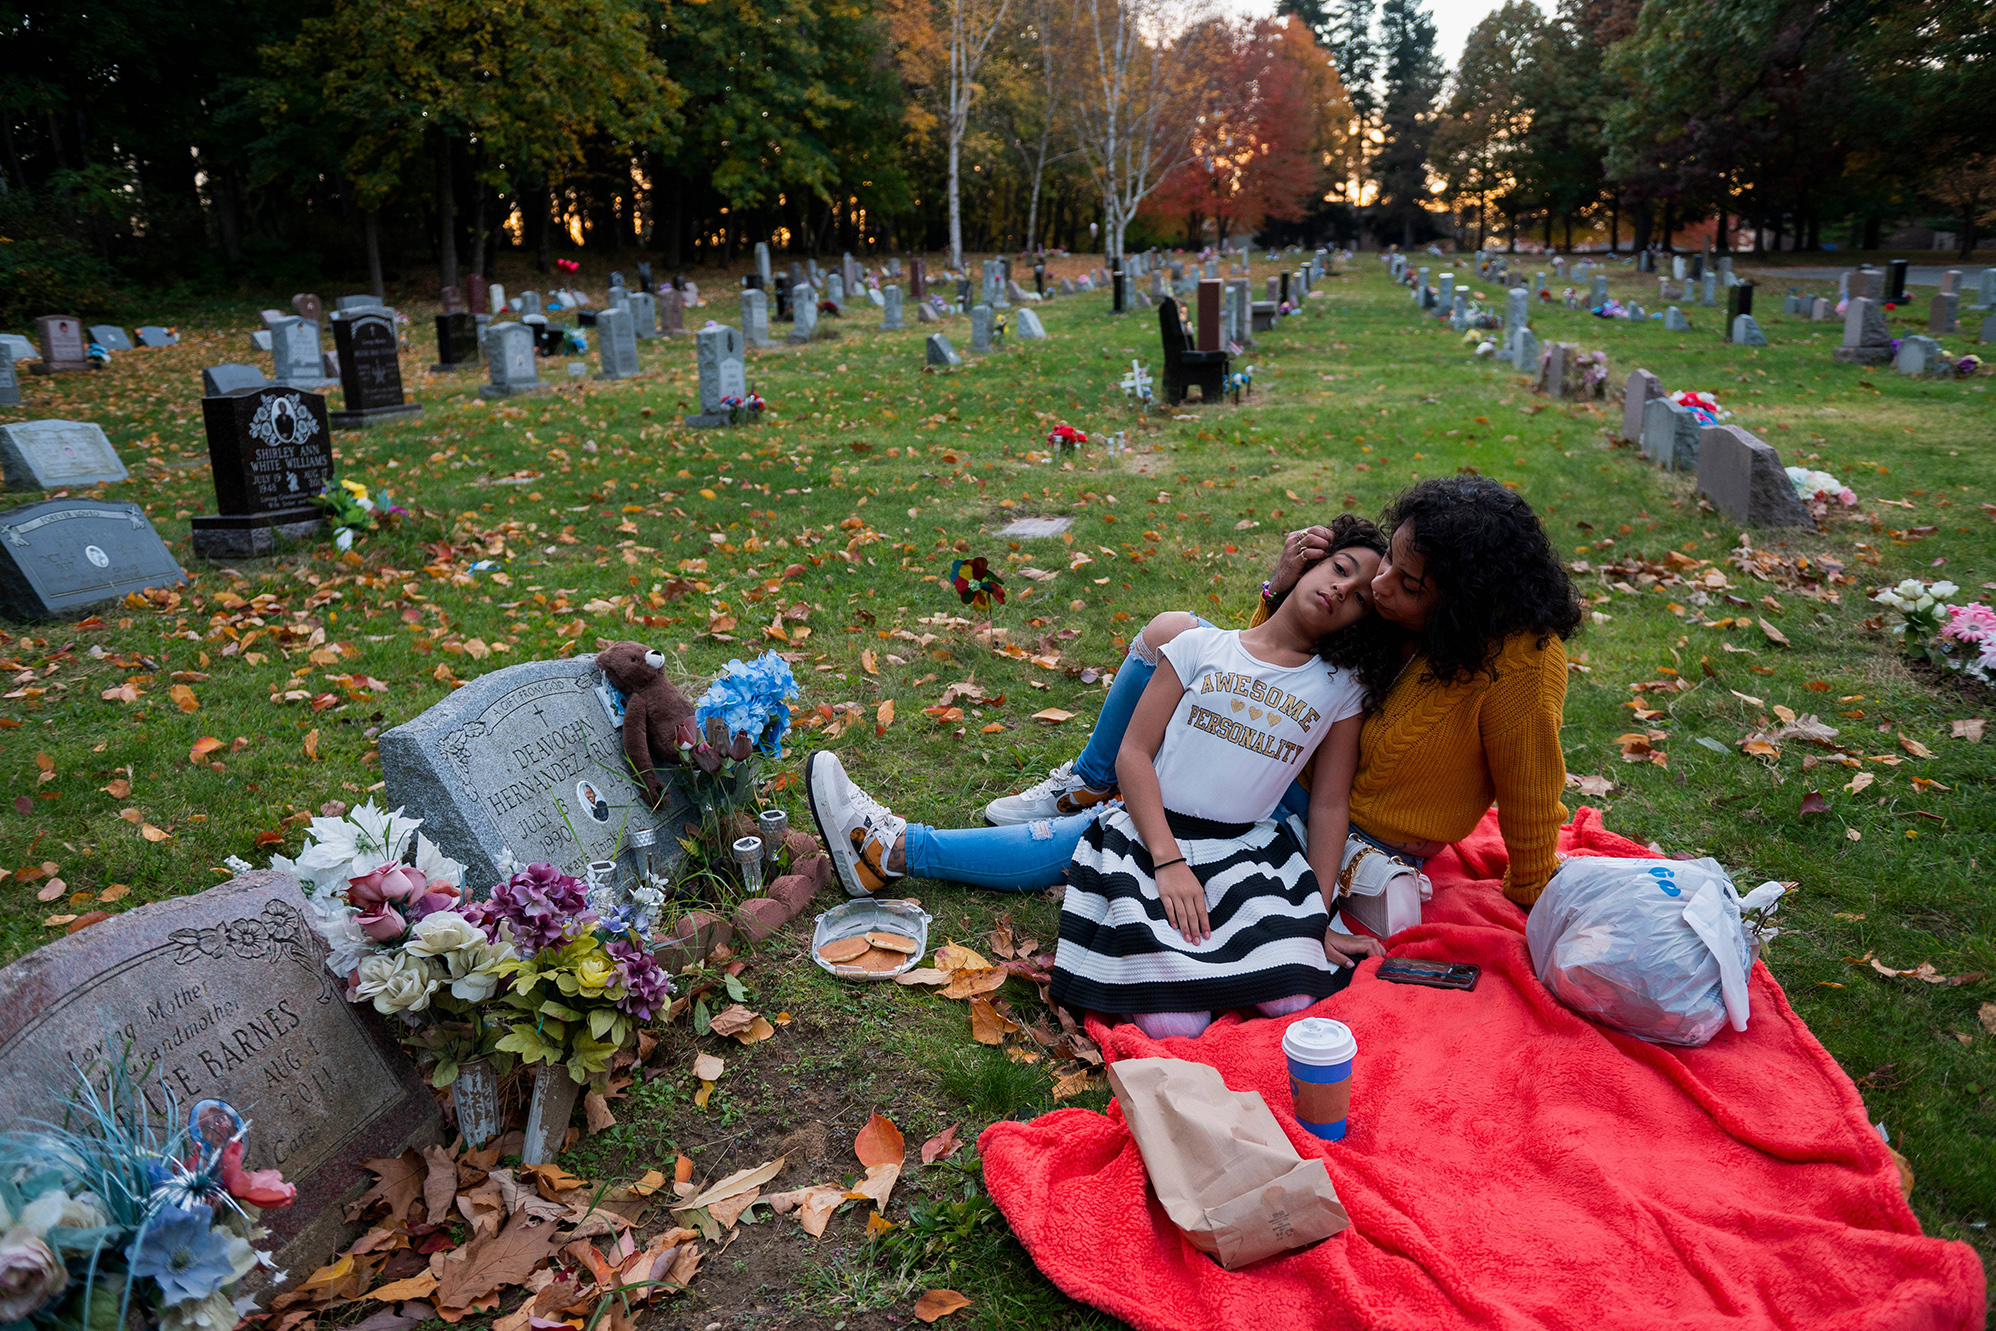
[806,477,1581,925]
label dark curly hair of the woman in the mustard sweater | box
[1379,477,1581,682]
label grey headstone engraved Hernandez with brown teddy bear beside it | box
[381,659,681,884]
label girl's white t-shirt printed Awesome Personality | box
[1156,629,1365,822]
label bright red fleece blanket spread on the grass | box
[978,808,1986,1331]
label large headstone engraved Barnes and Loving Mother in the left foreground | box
[0,870,445,1275]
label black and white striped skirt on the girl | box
[1054,808,1351,1014]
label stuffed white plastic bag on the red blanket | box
[1525,856,1782,1046]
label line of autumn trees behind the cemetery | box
[0,0,1996,319]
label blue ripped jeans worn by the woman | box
[906,615,1309,892]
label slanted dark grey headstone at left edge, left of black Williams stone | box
[0,499,184,618]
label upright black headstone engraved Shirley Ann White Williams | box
[194,385,333,559]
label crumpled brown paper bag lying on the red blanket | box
[1108,1058,1351,1271]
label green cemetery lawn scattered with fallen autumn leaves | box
[0,255,1996,1327]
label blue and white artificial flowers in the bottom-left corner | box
[0,1060,297,1331]
